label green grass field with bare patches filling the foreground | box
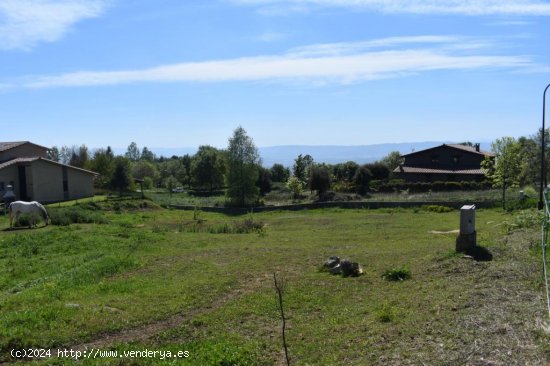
[0,201,550,365]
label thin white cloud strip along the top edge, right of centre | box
[230,0,550,16]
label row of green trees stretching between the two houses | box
[45,127,400,206]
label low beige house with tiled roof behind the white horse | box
[0,141,97,203]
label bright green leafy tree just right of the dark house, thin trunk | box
[482,137,521,209]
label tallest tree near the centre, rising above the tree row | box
[227,126,260,206]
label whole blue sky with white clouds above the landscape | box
[0,0,550,148]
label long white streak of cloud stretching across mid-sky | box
[19,36,534,88]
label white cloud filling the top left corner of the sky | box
[0,0,111,50]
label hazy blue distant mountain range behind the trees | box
[114,141,491,167]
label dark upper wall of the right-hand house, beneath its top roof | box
[405,147,484,170]
